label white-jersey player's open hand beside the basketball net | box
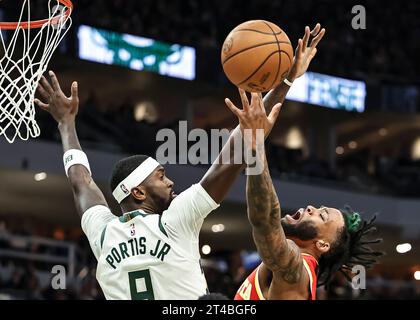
[34,71,79,124]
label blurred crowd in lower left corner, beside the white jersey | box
[0,216,104,300]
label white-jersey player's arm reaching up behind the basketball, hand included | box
[200,23,325,203]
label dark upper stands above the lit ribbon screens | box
[75,0,420,82]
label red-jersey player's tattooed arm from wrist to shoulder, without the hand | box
[246,151,303,283]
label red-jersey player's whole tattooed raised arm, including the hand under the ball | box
[227,87,303,283]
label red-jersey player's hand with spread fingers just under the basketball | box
[225,89,281,150]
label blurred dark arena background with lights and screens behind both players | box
[0,0,420,299]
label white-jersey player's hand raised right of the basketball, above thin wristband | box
[287,23,325,82]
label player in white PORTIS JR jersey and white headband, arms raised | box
[35,25,324,300]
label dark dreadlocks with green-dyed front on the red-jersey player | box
[318,206,384,288]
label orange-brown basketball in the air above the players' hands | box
[221,20,293,92]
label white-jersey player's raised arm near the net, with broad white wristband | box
[35,71,108,217]
